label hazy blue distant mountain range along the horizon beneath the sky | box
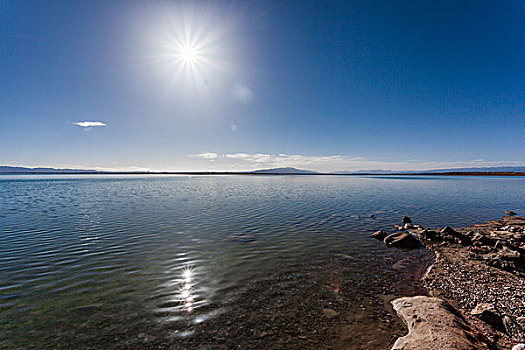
[0,166,525,175]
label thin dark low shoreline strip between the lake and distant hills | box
[0,171,525,176]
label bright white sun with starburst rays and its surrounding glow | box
[127,2,250,111]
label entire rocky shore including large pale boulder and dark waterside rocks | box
[373,213,525,349]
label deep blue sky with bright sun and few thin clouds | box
[0,0,525,171]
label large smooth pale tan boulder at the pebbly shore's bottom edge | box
[392,296,490,350]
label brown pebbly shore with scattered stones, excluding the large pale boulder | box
[388,217,525,349]
